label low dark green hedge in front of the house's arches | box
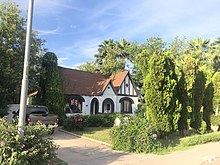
[83,114,117,127]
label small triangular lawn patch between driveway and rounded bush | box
[72,127,111,144]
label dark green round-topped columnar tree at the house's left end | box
[36,52,64,122]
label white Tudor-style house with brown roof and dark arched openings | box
[59,67,138,115]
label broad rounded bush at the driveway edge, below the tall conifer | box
[111,115,161,153]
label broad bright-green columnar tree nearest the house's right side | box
[144,52,179,135]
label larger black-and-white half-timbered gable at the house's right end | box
[118,74,137,96]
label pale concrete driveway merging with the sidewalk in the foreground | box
[52,130,220,165]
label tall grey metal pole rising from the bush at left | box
[18,0,34,138]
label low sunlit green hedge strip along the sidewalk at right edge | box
[180,132,220,147]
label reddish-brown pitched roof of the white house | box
[59,67,128,96]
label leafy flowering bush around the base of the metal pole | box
[0,119,57,165]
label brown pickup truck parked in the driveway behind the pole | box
[12,105,59,133]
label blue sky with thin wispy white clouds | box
[0,0,220,67]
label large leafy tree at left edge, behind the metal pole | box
[0,0,44,116]
